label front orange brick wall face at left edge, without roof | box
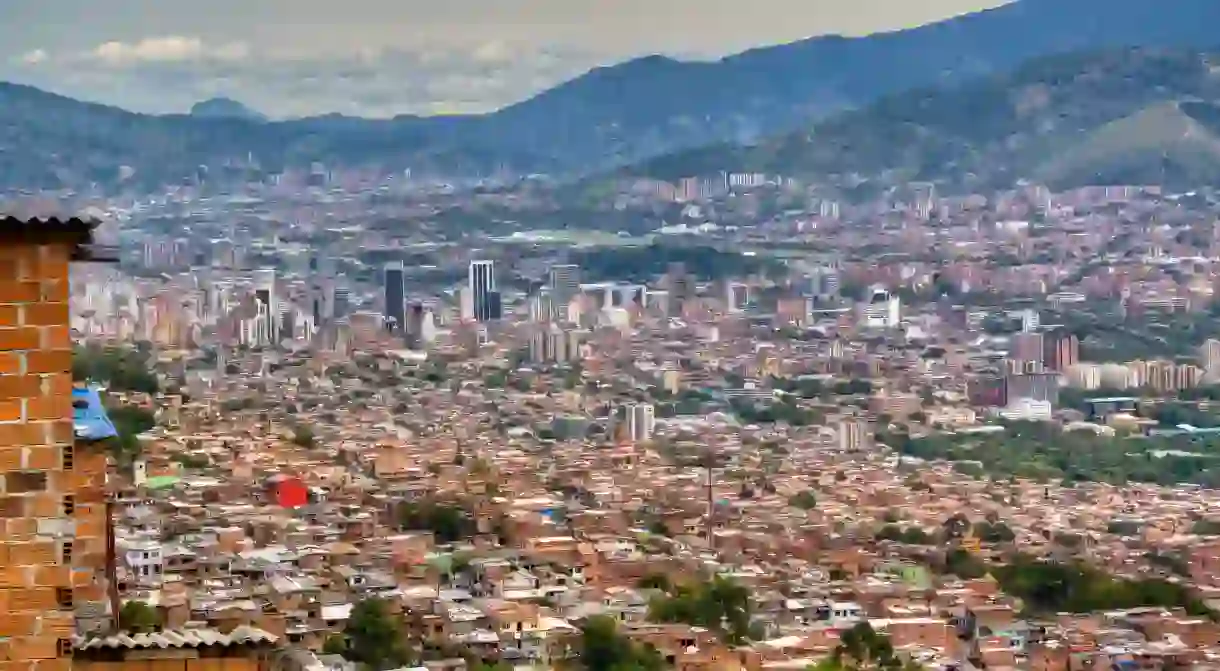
[0,237,79,671]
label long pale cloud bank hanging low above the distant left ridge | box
[0,35,611,118]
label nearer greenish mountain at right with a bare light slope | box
[621,49,1220,195]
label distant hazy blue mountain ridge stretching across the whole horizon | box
[0,0,1220,188]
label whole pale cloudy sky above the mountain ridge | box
[0,0,1003,118]
